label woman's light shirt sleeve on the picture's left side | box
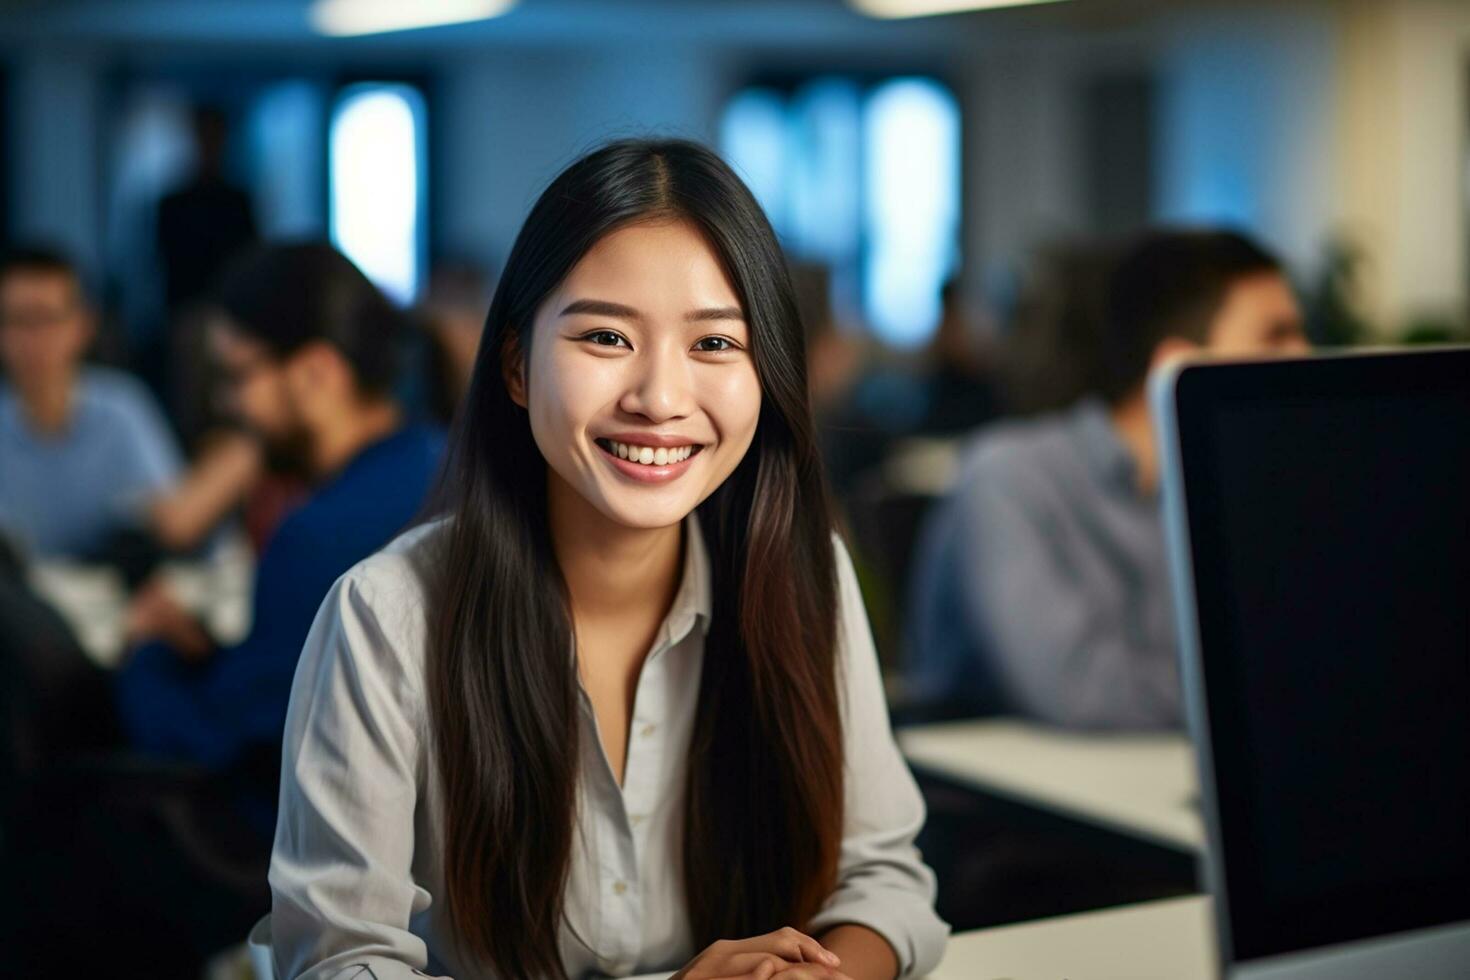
[270,570,443,980]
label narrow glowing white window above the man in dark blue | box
[328,84,426,304]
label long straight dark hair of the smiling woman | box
[428,140,844,977]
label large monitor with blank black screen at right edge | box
[1150,348,1470,980]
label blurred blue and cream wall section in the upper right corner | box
[1157,0,1470,335]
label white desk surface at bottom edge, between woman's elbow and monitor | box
[929,896,1217,980]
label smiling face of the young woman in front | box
[507,220,760,527]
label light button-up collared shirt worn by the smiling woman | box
[270,516,948,980]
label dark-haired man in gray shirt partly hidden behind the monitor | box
[910,231,1308,729]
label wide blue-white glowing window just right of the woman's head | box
[720,76,960,348]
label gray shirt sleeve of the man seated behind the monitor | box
[957,466,1179,729]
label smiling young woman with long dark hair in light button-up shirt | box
[270,141,947,980]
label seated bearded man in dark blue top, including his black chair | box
[7,244,442,980]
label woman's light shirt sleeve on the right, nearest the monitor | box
[810,541,950,977]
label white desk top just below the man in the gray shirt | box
[898,718,1204,851]
